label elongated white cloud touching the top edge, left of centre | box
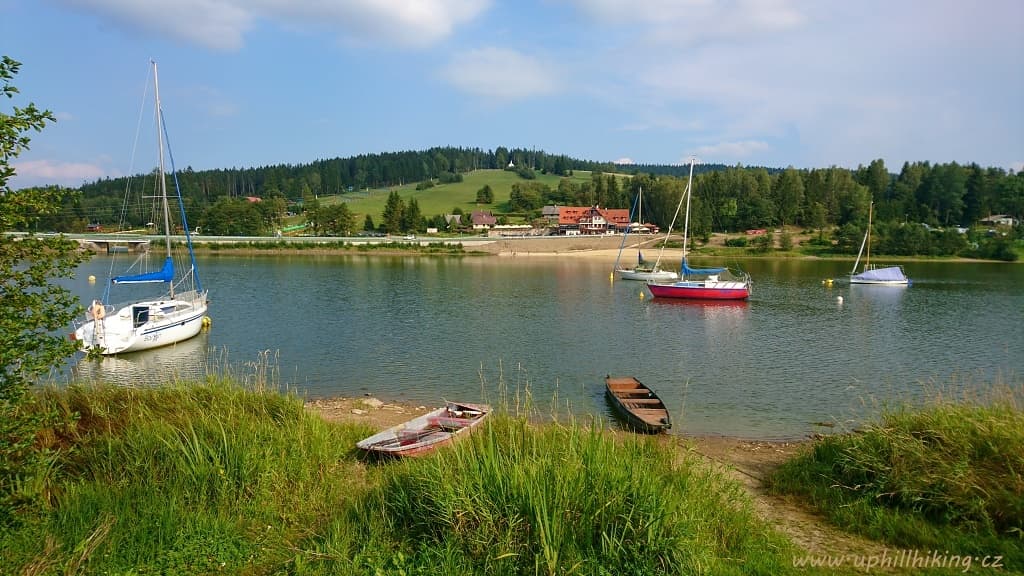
[60,0,489,51]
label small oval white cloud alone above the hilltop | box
[441,48,559,100]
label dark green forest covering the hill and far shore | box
[28,147,1024,255]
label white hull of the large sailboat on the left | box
[74,293,207,355]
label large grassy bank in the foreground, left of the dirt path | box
[0,379,792,574]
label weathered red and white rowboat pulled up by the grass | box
[355,402,490,456]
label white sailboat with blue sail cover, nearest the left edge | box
[72,61,210,355]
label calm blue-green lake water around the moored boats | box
[59,251,1024,438]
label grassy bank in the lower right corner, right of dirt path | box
[771,381,1024,571]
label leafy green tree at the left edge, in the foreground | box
[0,56,88,526]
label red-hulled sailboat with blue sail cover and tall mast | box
[647,158,751,300]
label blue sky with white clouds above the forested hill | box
[0,0,1024,189]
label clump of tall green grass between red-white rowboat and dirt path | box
[303,415,788,574]
